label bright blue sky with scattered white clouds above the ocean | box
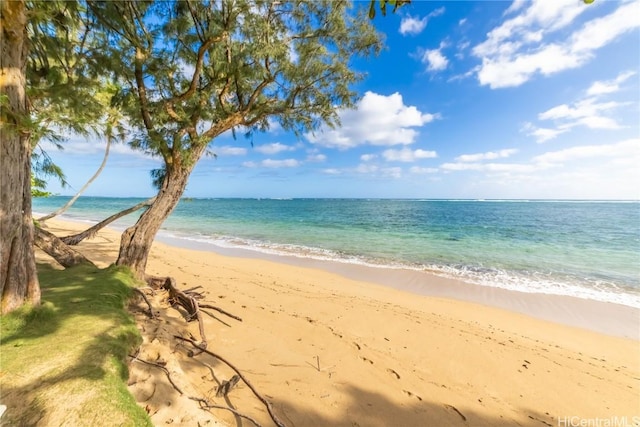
[42,0,640,199]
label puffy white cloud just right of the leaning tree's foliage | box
[305,92,440,150]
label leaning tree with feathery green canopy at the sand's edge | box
[88,0,381,278]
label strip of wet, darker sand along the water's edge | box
[156,231,640,341]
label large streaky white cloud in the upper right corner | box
[473,0,640,89]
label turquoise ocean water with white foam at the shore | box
[33,197,640,307]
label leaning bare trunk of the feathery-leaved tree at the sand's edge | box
[116,167,195,280]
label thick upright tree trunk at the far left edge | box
[0,0,40,314]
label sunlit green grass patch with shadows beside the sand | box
[0,265,152,426]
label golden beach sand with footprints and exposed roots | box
[38,220,640,427]
